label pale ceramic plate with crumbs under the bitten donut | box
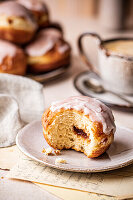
[16,121,133,172]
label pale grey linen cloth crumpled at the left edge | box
[0,74,44,147]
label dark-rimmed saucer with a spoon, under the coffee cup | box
[74,71,133,112]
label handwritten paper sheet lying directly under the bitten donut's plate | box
[8,156,133,196]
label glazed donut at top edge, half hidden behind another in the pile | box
[17,0,49,27]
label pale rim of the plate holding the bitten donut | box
[16,120,133,173]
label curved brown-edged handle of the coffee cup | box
[78,32,102,75]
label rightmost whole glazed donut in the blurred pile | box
[25,28,70,73]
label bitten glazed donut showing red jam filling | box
[42,96,115,158]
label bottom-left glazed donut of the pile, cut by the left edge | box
[0,40,26,75]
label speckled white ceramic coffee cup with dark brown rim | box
[78,32,133,94]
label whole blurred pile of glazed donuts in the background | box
[0,0,71,75]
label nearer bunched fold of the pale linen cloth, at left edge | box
[0,95,24,147]
